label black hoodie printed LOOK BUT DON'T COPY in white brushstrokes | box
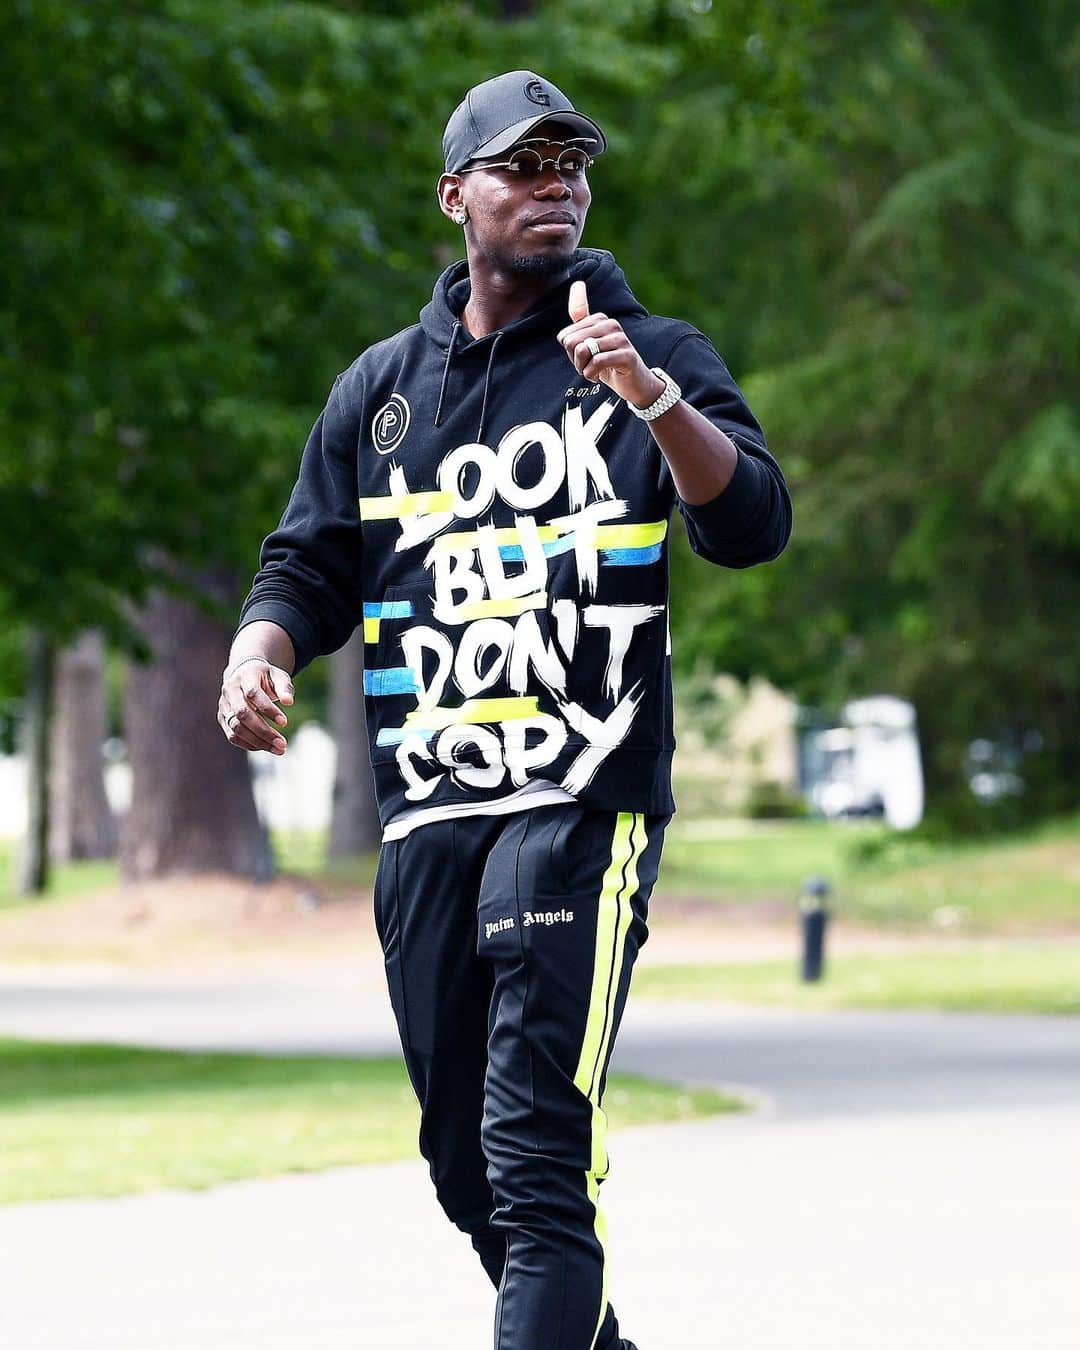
[238,248,791,826]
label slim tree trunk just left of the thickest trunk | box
[49,629,116,861]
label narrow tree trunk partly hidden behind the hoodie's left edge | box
[328,628,382,857]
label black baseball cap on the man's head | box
[443,70,608,173]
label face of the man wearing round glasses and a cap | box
[440,119,593,275]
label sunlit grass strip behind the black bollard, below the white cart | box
[659,815,1080,933]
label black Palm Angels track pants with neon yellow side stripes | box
[375,802,671,1350]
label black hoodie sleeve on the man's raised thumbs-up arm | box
[659,331,792,567]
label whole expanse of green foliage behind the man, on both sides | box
[0,0,1080,819]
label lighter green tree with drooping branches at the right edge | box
[756,4,1080,811]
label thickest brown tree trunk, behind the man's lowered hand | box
[120,556,271,880]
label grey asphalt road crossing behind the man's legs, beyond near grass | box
[0,973,1080,1119]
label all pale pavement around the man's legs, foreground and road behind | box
[0,973,1080,1350]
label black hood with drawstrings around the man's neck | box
[420,248,648,441]
